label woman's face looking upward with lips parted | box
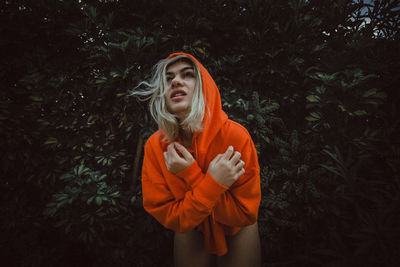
[165,61,196,120]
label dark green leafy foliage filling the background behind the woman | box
[0,0,400,267]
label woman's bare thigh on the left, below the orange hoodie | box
[174,230,215,267]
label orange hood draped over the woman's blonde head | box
[168,52,228,167]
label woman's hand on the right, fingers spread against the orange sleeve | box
[208,146,245,187]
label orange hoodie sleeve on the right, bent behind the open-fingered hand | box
[214,135,261,227]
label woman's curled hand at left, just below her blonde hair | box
[164,142,194,174]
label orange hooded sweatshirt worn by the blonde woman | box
[142,53,261,256]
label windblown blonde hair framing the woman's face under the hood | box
[130,55,205,142]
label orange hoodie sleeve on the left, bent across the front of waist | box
[142,141,227,233]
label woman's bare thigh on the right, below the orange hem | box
[217,223,261,267]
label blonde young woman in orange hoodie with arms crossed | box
[133,53,261,267]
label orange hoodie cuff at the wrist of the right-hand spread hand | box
[193,173,228,209]
